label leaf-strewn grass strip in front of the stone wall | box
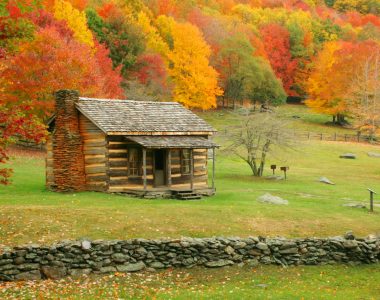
[0,265,380,300]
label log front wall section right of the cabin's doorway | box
[171,149,208,188]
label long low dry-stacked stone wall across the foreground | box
[0,233,380,280]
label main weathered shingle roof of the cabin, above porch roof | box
[76,97,215,135]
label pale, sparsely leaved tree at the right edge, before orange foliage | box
[347,51,380,140]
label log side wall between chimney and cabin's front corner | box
[79,114,109,191]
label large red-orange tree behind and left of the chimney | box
[0,26,123,118]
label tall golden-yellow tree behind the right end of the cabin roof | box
[168,22,222,109]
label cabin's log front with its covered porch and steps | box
[108,136,217,199]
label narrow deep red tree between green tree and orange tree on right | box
[260,24,297,96]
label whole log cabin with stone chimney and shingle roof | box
[46,90,217,199]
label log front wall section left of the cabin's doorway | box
[107,136,153,192]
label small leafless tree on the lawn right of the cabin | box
[225,113,295,177]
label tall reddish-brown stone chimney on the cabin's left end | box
[51,90,86,192]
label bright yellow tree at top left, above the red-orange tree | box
[54,0,94,47]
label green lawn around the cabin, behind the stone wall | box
[0,137,380,246]
